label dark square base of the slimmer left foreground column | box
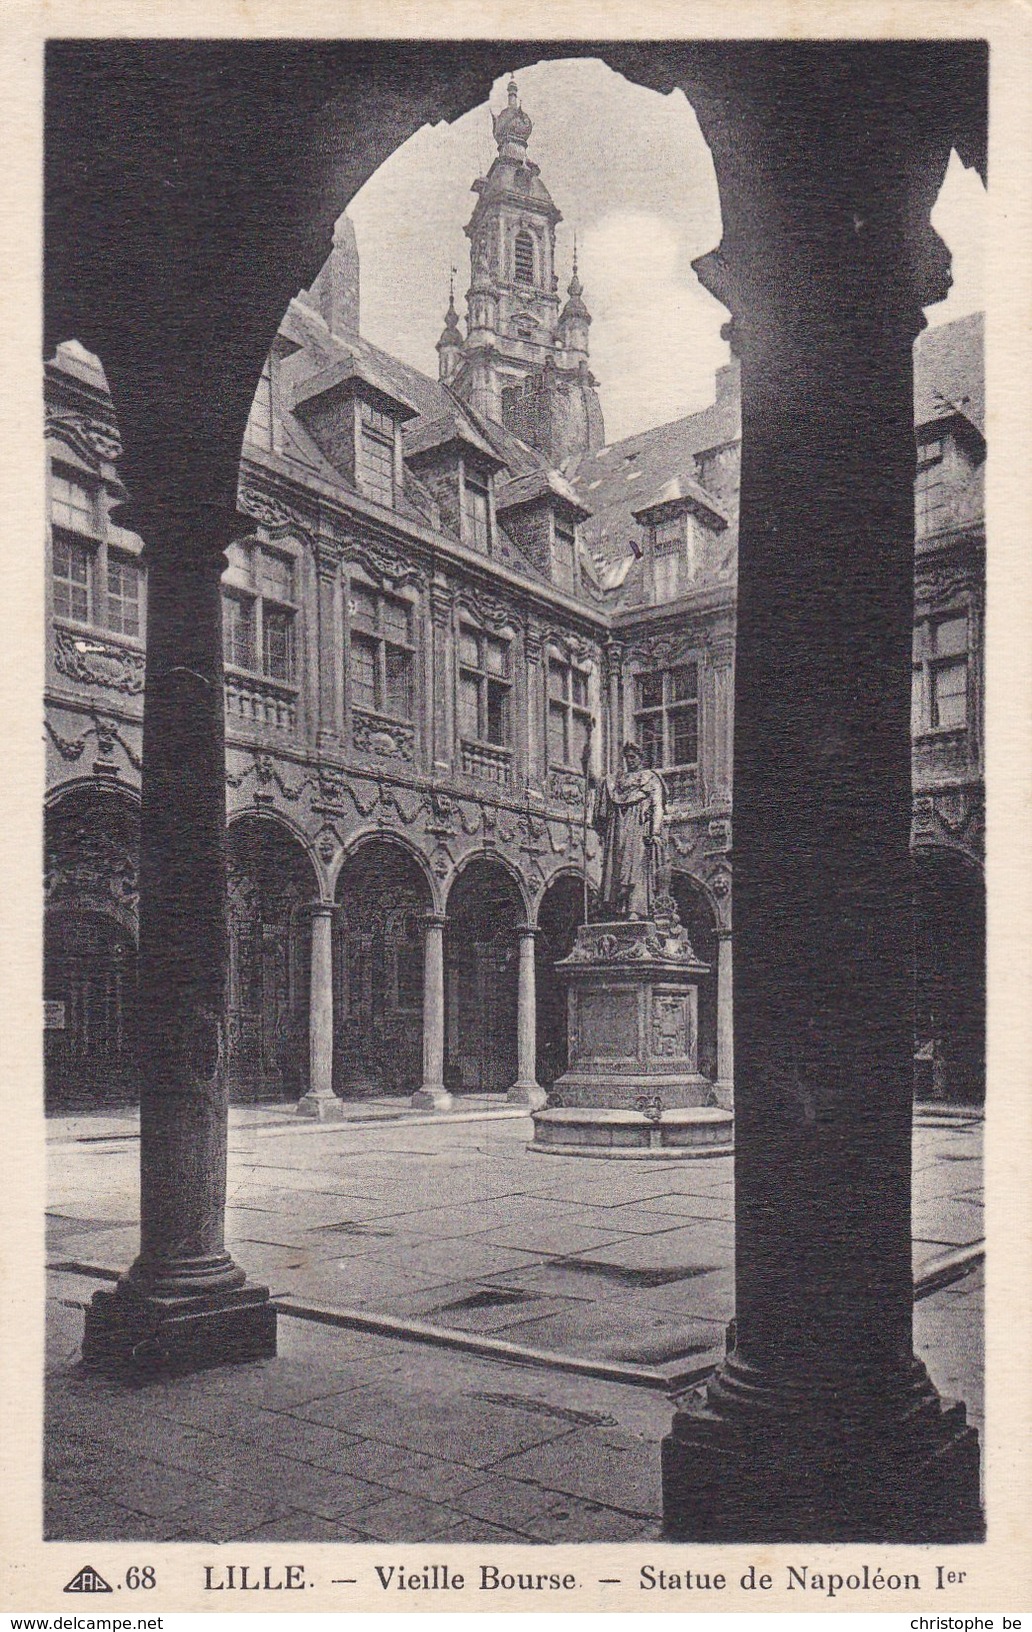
[82,1283,276,1374]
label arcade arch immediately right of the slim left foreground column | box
[225,811,318,1102]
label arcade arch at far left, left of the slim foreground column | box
[42,780,139,1110]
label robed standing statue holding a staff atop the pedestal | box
[591,743,666,919]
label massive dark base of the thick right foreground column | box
[663,1374,985,1544]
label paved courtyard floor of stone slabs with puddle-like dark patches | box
[47,1111,981,1542]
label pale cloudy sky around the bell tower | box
[348,59,986,442]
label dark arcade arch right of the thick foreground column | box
[911,844,986,1105]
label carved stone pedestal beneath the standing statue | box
[534,920,732,1155]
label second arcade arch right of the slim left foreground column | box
[333,829,438,1098]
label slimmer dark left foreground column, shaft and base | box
[83,511,276,1368]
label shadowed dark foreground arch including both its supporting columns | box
[66,41,986,1542]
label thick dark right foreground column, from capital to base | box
[663,124,981,1542]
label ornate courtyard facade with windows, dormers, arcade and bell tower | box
[46,101,985,1100]
